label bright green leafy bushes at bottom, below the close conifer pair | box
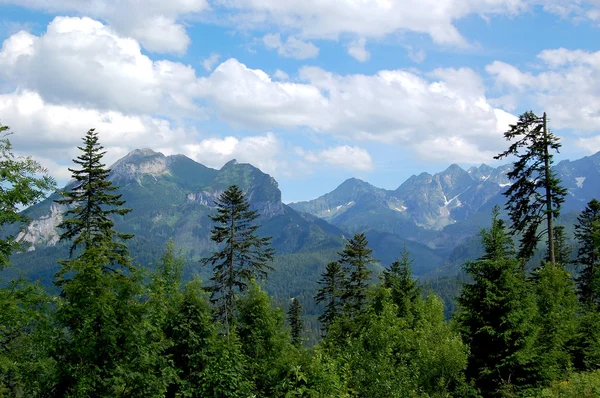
[323,287,467,397]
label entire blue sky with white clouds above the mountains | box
[0,0,600,202]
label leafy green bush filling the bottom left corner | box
[0,279,57,397]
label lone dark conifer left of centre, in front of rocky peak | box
[201,185,275,333]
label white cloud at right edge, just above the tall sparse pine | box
[486,48,600,133]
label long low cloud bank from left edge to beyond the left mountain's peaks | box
[0,91,286,183]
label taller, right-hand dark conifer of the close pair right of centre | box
[338,233,375,316]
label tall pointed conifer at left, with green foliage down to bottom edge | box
[53,129,169,397]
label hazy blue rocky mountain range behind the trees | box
[4,149,600,295]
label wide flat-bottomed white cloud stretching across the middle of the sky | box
[199,59,513,161]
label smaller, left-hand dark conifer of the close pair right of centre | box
[315,261,344,332]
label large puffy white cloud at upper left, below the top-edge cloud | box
[0,17,200,116]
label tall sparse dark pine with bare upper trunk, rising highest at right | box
[494,112,567,266]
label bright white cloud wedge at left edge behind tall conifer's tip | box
[0,91,190,182]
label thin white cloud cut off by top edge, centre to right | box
[213,0,531,45]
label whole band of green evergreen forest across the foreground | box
[0,112,600,398]
